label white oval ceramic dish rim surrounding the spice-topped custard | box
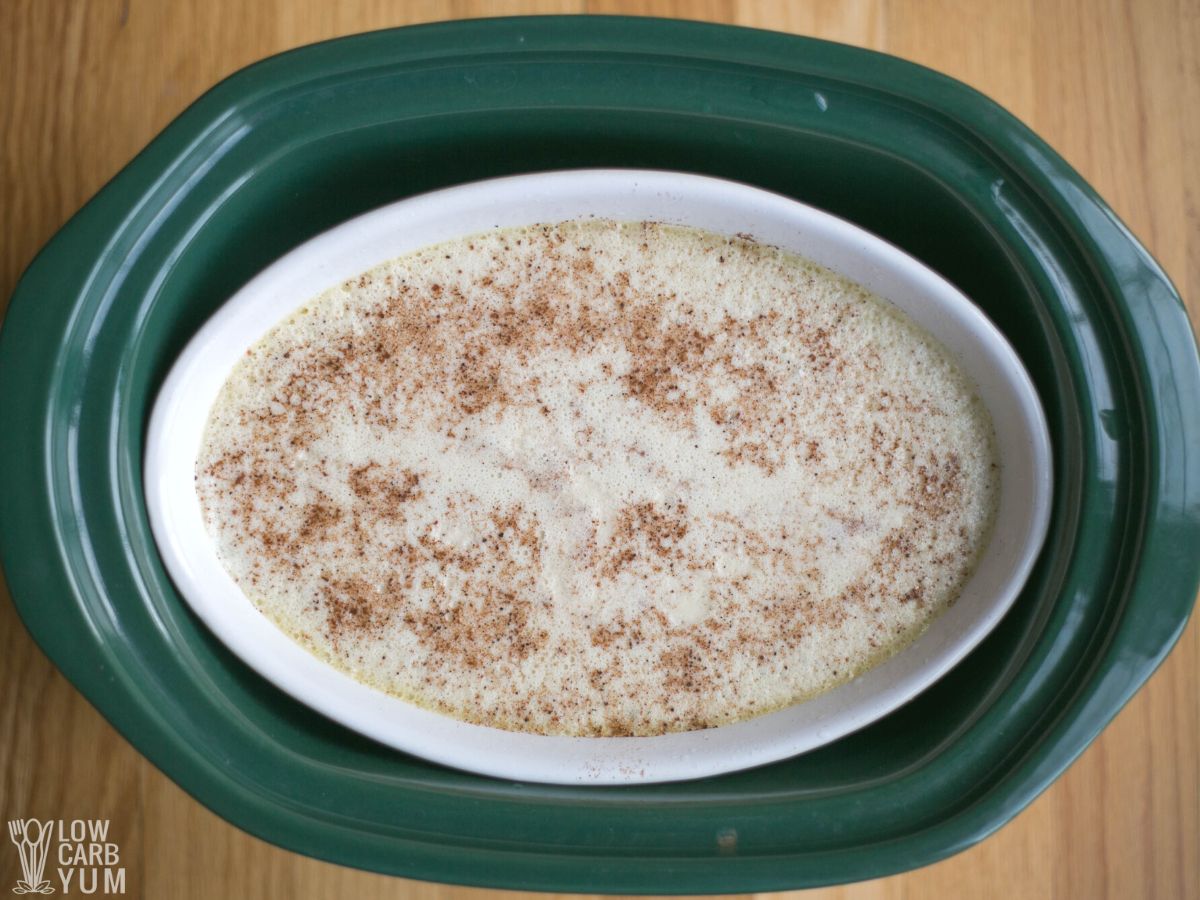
[144,169,1051,785]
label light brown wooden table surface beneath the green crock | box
[0,0,1200,900]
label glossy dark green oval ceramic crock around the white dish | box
[0,18,1200,893]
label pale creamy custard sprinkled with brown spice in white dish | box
[197,221,998,734]
